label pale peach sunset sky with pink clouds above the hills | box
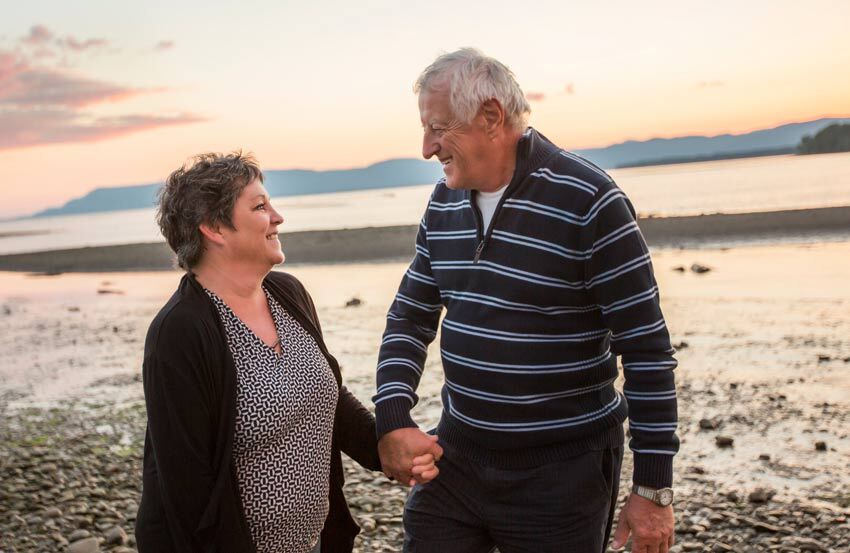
[0,0,850,218]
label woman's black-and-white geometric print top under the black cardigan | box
[206,288,339,553]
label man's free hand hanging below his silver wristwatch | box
[611,494,676,553]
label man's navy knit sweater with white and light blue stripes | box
[374,129,678,487]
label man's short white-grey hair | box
[413,48,531,130]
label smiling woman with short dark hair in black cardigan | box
[136,153,437,553]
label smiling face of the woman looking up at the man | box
[221,179,285,268]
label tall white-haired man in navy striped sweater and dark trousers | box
[374,49,678,553]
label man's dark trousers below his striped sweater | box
[404,444,623,553]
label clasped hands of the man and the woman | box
[378,428,443,486]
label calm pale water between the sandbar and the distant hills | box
[0,153,850,254]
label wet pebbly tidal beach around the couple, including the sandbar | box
[0,223,850,553]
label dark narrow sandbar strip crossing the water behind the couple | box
[0,206,850,273]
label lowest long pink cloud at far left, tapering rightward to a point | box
[0,109,207,150]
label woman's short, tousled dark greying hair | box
[156,152,263,271]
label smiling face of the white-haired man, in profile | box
[419,84,496,190]
